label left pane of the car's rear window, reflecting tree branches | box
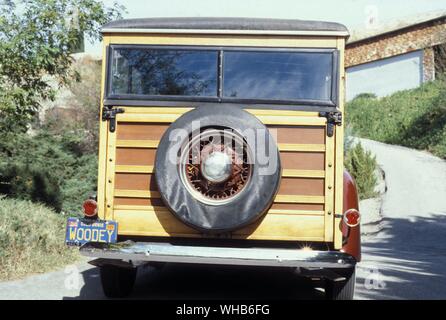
[110,48,218,97]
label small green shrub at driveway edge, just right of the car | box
[344,143,378,199]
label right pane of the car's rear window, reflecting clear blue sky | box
[223,51,333,100]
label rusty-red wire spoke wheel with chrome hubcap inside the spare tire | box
[179,128,252,205]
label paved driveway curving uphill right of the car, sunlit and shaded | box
[357,140,446,299]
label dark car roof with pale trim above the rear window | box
[102,17,349,37]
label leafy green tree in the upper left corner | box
[0,0,124,133]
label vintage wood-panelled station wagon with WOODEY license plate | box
[66,18,361,299]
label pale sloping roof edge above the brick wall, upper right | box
[348,10,446,44]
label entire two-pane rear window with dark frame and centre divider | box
[107,45,337,106]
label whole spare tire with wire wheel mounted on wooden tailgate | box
[155,104,281,233]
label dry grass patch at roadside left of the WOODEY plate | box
[0,197,79,280]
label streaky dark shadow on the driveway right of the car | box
[356,213,446,299]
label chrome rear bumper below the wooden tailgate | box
[80,242,356,269]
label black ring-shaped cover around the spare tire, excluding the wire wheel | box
[155,104,281,233]
